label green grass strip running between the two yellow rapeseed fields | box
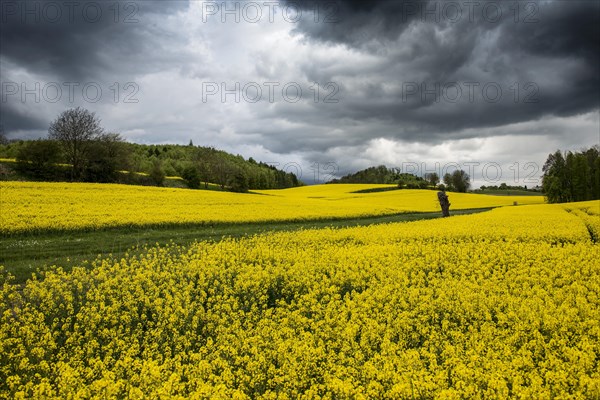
[0,208,491,283]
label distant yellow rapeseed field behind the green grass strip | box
[0,182,543,234]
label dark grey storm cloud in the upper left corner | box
[0,0,187,80]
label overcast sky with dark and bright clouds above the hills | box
[0,0,600,187]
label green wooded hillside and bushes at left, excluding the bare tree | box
[0,136,302,192]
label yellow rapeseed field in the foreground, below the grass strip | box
[0,202,600,399]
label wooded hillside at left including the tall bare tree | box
[0,107,302,192]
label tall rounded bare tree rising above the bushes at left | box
[48,107,104,181]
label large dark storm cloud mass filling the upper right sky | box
[280,0,600,148]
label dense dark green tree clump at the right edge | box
[542,145,600,203]
